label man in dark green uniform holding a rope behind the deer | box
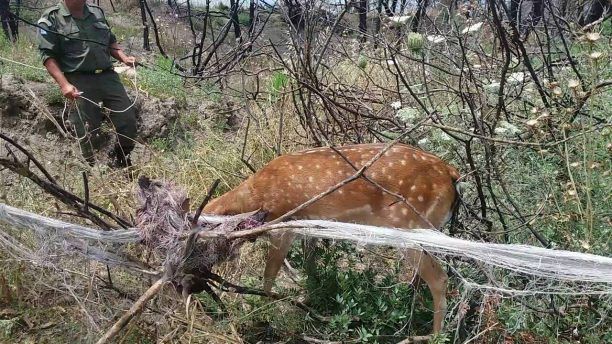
[38,0,136,167]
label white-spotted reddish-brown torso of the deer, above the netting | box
[224,144,459,228]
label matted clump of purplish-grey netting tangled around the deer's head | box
[136,177,263,275]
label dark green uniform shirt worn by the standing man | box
[38,1,117,73]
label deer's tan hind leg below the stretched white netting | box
[406,250,448,333]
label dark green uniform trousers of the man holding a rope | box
[66,71,136,165]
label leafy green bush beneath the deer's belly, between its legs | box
[290,242,432,343]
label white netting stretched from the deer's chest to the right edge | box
[266,220,612,296]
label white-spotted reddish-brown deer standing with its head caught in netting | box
[204,143,460,333]
